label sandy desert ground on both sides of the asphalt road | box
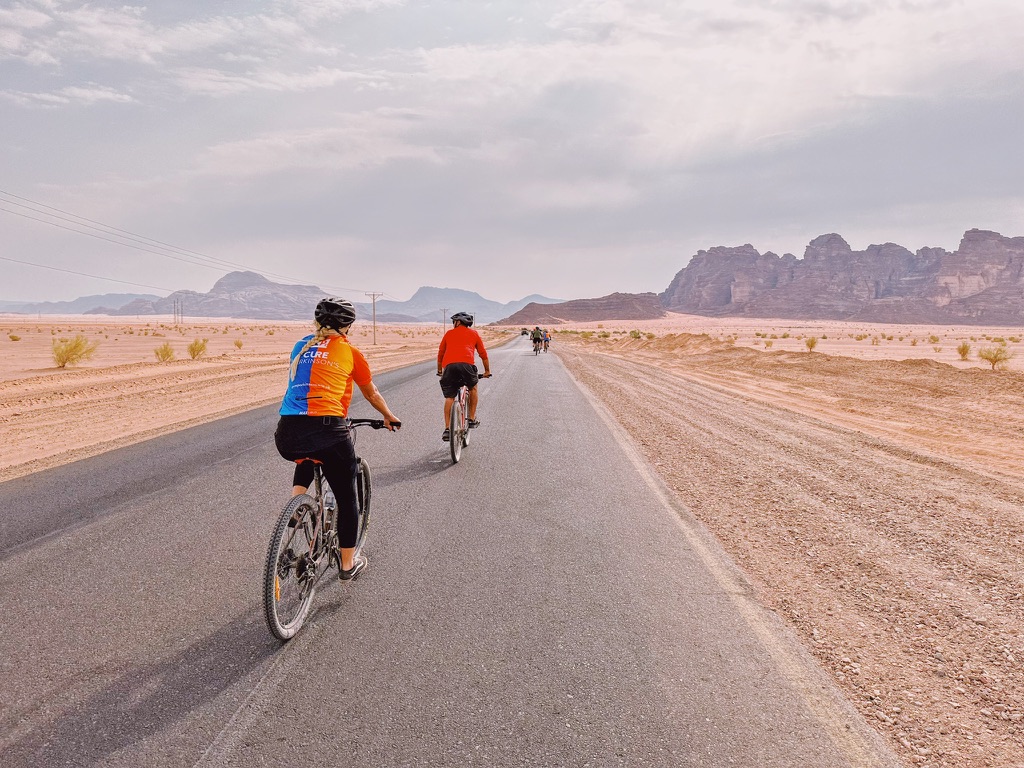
[0,315,1024,768]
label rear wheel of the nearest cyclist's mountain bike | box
[263,494,324,640]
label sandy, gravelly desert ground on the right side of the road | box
[554,318,1024,768]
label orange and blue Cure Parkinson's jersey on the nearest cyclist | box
[281,335,373,417]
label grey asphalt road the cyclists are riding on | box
[0,339,897,768]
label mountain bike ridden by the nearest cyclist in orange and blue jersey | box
[263,419,397,640]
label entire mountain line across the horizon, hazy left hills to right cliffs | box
[9,229,1024,326]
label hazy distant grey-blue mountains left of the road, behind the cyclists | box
[66,271,558,323]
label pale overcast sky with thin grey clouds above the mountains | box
[0,0,1024,301]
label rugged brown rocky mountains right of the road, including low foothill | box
[503,229,1024,326]
